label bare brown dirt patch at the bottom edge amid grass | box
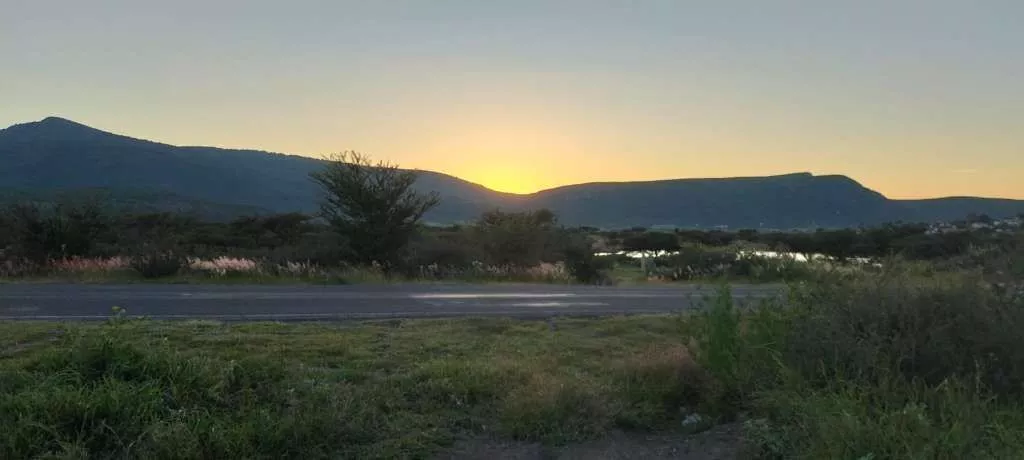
[435,424,741,460]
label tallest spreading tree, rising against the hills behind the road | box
[310,152,440,269]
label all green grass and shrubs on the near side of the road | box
[0,271,1024,460]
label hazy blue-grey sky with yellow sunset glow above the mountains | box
[0,0,1024,199]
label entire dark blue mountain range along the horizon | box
[0,117,1024,228]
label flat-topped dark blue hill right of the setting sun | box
[520,173,889,228]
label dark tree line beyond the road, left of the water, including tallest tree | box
[0,153,599,282]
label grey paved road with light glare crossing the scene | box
[0,285,780,321]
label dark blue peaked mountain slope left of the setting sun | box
[0,118,507,221]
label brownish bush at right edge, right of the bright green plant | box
[785,267,1024,393]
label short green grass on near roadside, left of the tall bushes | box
[0,317,695,458]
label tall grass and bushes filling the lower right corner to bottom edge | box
[690,267,1024,459]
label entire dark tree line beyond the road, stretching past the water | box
[0,153,1015,282]
